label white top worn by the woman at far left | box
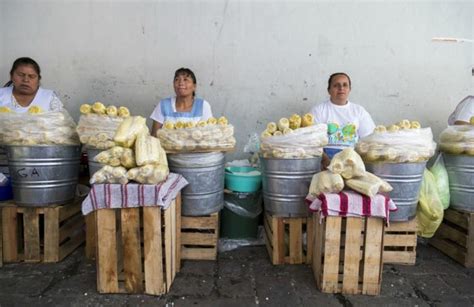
[0,86,63,113]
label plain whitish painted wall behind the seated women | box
[0,0,474,158]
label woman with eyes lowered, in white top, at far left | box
[0,57,63,113]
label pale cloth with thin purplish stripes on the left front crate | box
[82,173,188,215]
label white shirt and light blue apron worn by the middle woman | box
[150,97,212,124]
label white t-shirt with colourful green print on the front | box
[311,100,375,147]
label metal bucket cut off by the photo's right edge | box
[443,154,474,212]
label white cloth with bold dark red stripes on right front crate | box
[306,191,397,221]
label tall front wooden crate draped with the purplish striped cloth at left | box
[95,197,181,295]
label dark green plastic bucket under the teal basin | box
[220,191,262,239]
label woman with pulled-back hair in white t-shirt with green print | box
[310,72,375,165]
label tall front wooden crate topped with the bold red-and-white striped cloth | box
[312,213,384,295]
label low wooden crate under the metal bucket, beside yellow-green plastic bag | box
[383,218,417,265]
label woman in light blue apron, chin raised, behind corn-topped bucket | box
[150,68,212,135]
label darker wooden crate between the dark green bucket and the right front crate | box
[264,212,313,265]
